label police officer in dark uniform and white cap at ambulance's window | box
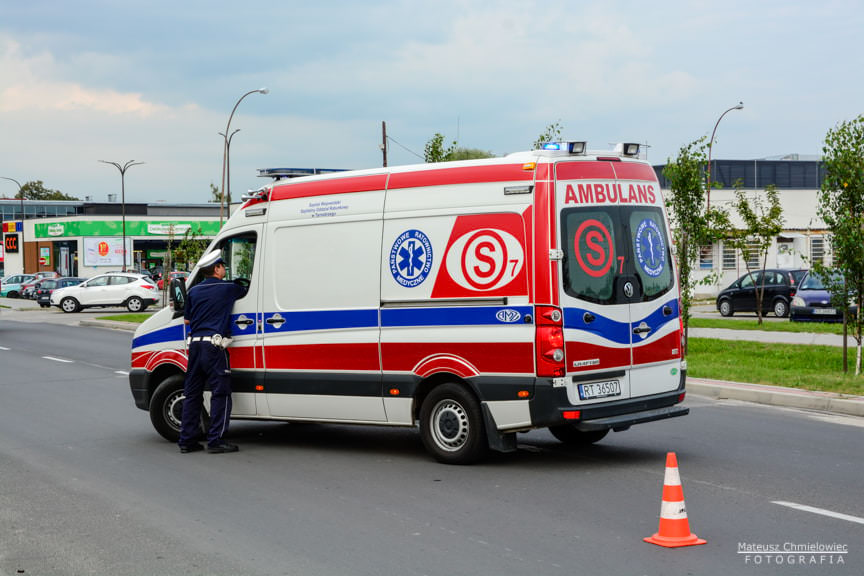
[179,250,246,454]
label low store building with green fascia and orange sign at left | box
[0,199,220,277]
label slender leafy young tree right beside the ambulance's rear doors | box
[663,137,729,355]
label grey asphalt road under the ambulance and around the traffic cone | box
[0,315,864,576]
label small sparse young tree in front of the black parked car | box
[728,180,788,324]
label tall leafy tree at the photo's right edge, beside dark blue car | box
[814,115,864,376]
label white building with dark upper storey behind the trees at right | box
[654,155,830,296]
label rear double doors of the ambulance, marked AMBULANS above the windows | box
[556,161,680,404]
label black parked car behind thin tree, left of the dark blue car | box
[717,268,807,318]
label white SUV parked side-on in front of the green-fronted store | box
[51,272,159,312]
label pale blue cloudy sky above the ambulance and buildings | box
[0,0,864,203]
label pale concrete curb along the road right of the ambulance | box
[687,378,864,417]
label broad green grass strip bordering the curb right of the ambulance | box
[687,338,864,396]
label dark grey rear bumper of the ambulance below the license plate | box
[531,370,690,432]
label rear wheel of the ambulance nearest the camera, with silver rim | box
[420,383,487,464]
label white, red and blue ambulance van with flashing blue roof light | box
[129,141,689,464]
